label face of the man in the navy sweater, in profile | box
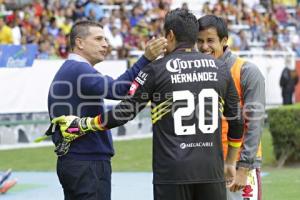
[76,26,108,65]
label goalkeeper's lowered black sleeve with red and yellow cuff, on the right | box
[223,71,244,147]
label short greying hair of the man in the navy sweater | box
[70,20,103,50]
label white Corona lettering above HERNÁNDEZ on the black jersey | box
[166,58,218,73]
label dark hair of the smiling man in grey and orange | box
[198,15,228,40]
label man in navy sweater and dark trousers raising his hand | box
[48,21,166,200]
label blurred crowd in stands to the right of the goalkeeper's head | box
[202,0,300,56]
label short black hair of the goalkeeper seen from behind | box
[164,8,198,45]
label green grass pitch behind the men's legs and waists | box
[0,130,300,200]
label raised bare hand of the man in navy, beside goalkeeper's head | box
[144,37,167,61]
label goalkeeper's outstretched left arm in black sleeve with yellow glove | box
[52,65,155,136]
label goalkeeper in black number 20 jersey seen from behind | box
[52,9,243,200]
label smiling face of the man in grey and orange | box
[197,28,227,58]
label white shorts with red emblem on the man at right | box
[227,168,262,200]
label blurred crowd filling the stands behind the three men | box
[0,0,300,59]
